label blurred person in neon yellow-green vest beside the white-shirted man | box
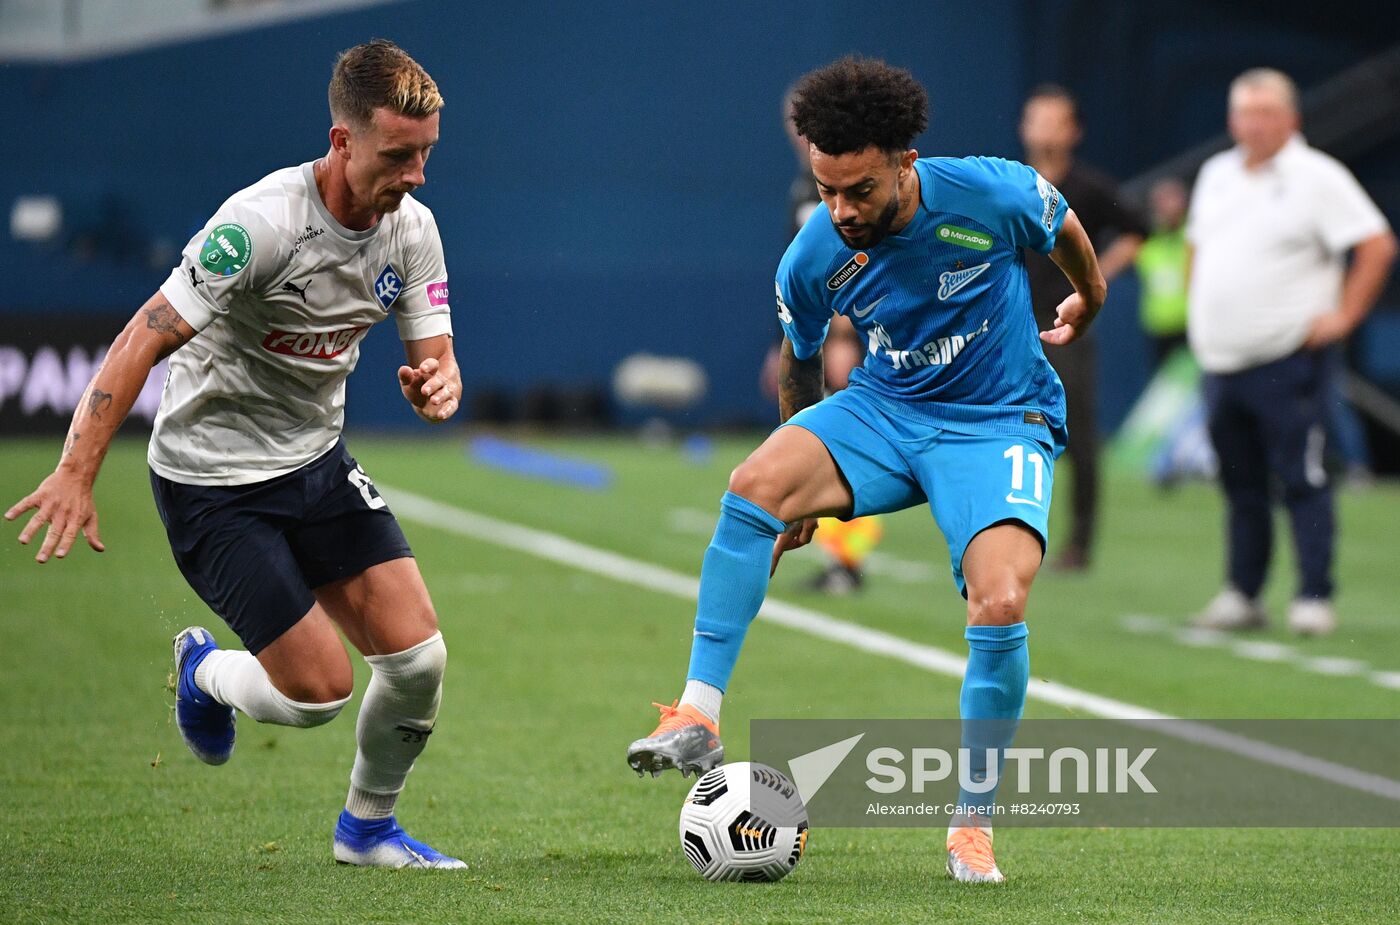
[1135,176,1187,372]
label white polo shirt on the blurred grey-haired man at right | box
[1186,136,1387,372]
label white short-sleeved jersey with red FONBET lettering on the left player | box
[147,162,452,486]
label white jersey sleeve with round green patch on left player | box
[161,202,277,330]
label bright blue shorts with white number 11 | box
[784,386,1058,596]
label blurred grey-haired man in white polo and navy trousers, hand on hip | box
[1186,69,1396,635]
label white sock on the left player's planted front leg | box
[346,633,447,819]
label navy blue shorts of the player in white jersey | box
[151,441,413,655]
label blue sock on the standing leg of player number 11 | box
[958,623,1030,806]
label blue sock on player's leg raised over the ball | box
[686,491,787,690]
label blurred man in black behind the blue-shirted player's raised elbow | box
[1021,84,1147,571]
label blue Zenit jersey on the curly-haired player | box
[777,157,1068,448]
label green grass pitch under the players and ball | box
[0,434,1400,925]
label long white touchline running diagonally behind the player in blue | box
[375,483,1400,800]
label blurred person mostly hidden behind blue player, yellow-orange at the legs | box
[760,88,885,595]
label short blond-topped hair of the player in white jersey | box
[328,39,442,129]
